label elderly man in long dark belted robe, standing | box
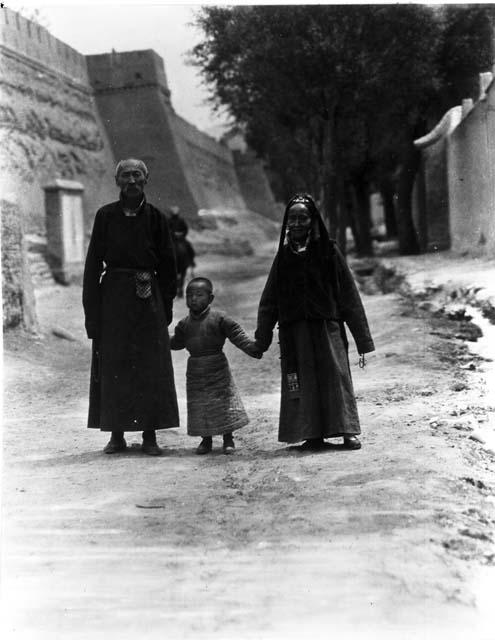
[83,158,179,455]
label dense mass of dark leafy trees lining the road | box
[193,5,493,254]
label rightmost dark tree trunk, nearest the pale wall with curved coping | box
[397,142,421,255]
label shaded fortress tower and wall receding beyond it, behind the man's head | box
[87,50,245,219]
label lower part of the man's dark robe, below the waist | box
[88,272,179,431]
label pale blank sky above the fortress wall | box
[4,0,232,134]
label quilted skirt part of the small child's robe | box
[186,352,249,438]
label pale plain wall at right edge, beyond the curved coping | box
[447,82,495,254]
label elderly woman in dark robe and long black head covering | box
[255,194,374,450]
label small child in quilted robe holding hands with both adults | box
[170,278,261,455]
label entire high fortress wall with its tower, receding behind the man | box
[0,9,280,241]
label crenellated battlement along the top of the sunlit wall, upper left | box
[0,7,89,87]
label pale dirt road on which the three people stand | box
[2,249,495,640]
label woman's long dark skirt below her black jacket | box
[279,320,361,443]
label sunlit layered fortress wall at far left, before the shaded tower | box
[0,8,117,233]
